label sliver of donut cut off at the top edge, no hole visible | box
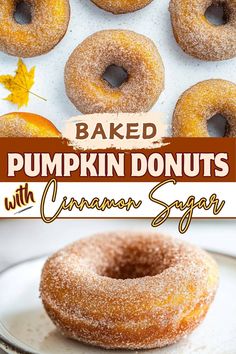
[92,0,152,14]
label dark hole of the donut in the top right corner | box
[205,2,228,26]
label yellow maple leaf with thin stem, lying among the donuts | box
[0,59,46,108]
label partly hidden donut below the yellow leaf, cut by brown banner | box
[0,112,61,138]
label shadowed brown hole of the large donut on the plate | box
[100,244,175,280]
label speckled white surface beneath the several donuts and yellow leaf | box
[0,0,236,133]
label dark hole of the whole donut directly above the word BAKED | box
[102,65,128,88]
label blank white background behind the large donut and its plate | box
[0,219,236,268]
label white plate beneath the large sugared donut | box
[0,254,236,354]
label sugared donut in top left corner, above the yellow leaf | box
[0,0,70,58]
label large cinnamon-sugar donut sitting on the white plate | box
[40,232,218,349]
